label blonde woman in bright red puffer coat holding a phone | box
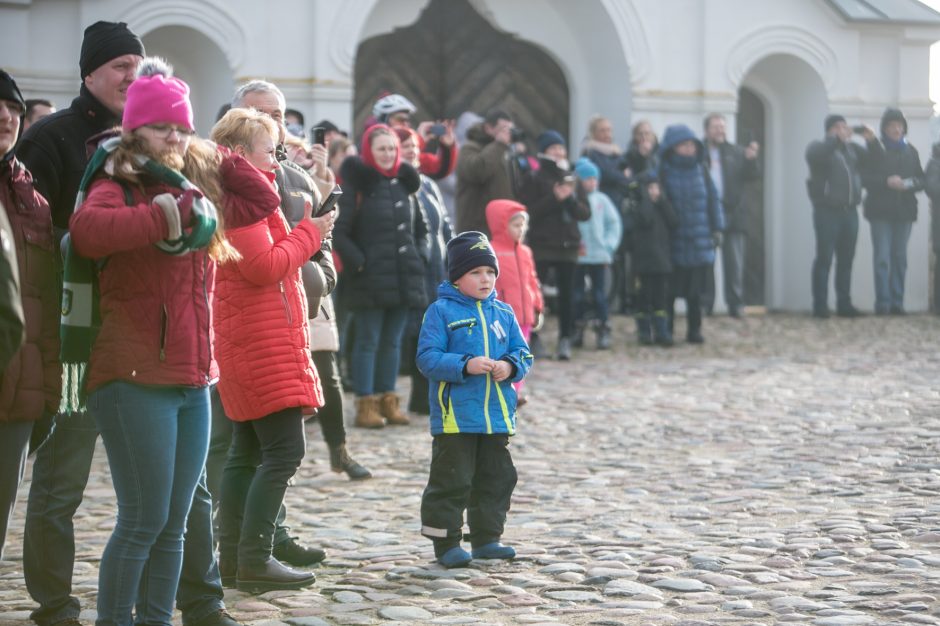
[212,109,333,592]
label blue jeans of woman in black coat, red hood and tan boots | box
[352,307,408,397]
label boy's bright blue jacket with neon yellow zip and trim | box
[417,281,532,435]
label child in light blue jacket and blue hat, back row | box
[574,157,623,350]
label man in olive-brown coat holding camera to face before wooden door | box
[457,110,521,237]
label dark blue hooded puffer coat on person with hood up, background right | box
[659,124,725,267]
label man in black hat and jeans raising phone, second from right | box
[806,114,878,319]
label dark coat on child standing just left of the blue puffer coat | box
[631,186,679,274]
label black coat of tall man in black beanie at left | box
[16,85,121,238]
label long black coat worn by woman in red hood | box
[333,157,429,309]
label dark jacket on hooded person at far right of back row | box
[862,142,924,222]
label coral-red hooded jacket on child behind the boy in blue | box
[486,200,544,327]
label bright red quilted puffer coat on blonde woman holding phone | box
[215,157,323,422]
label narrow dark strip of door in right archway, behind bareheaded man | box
[735,87,767,305]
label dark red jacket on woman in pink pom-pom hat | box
[69,178,218,392]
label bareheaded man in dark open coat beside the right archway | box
[703,113,760,317]
